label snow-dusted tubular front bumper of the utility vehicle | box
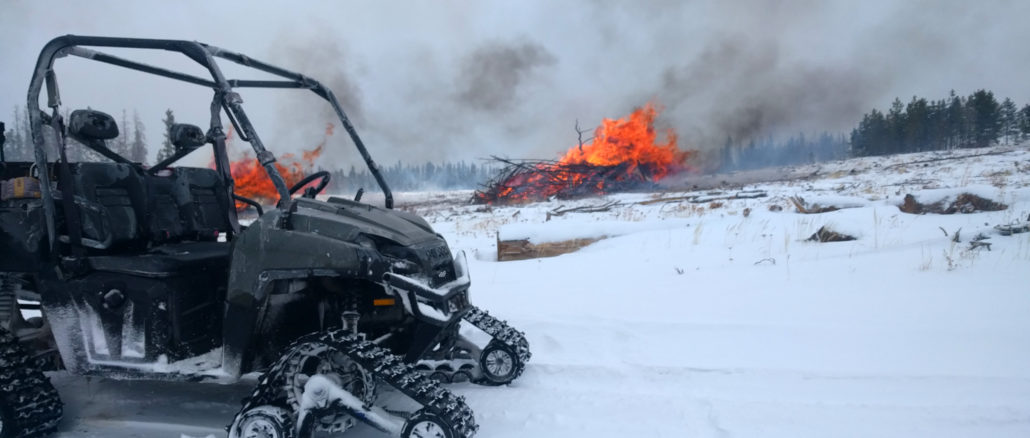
[383,251,472,326]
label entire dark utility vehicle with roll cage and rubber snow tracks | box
[0,35,529,438]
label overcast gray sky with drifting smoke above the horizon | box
[0,0,1030,168]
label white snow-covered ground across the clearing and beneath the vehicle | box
[48,147,1030,438]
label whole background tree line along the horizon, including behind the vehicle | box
[5,90,1030,182]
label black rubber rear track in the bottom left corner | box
[0,329,64,438]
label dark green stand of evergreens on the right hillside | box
[851,90,1030,157]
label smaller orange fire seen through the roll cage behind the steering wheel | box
[230,124,335,210]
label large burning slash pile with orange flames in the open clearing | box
[473,103,691,204]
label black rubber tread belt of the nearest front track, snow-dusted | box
[237,330,479,438]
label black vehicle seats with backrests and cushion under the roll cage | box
[76,163,232,278]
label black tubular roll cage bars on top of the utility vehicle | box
[28,35,393,249]
